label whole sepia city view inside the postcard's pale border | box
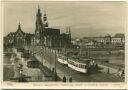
[3,1,126,83]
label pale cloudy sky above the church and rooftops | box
[4,1,126,37]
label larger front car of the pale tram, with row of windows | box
[68,58,91,73]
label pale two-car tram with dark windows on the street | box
[58,55,93,73]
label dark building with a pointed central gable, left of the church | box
[4,24,32,47]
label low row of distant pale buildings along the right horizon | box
[82,34,125,48]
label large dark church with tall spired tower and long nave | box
[34,8,71,47]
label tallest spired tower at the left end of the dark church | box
[35,6,44,45]
